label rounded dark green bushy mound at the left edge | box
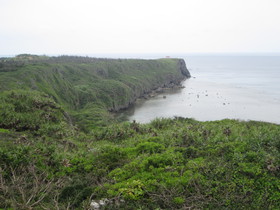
[0,90,72,137]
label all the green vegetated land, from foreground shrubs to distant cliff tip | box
[0,55,280,209]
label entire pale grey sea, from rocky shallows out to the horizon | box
[121,56,280,124]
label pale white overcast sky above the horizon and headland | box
[0,0,280,55]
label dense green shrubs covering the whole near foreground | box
[0,118,280,209]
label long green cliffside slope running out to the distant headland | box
[0,55,190,127]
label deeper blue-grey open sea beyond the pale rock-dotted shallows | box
[186,56,280,98]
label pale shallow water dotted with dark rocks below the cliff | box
[122,78,280,124]
